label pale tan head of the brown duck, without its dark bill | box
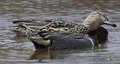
[83,11,108,31]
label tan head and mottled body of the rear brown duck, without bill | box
[10,11,108,35]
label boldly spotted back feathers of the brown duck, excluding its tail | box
[40,22,89,35]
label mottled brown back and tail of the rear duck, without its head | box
[11,18,89,37]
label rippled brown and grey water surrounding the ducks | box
[0,0,120,64]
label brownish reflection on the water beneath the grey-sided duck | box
[29,45,107,62]
